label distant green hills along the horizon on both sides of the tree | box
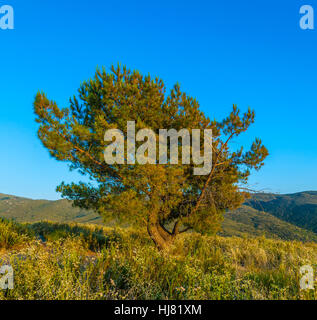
[0,191,317,242]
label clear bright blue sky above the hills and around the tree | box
[0,0,317,199]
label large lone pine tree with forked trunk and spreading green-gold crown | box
[34,66,268,249]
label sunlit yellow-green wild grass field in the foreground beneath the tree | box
[0,220,317,300]
